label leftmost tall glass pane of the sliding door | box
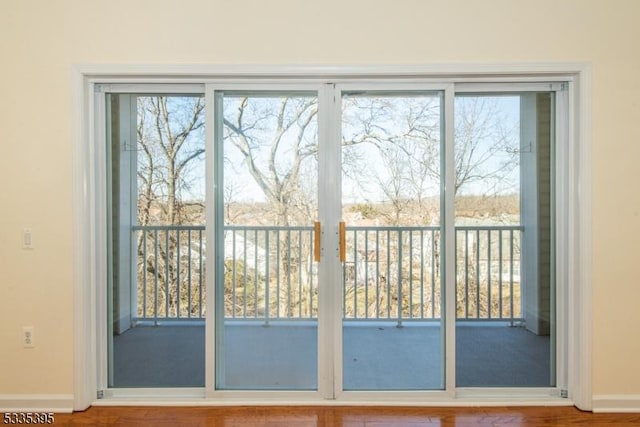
[107,94,206,388]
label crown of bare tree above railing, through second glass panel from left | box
[224,97,318,225]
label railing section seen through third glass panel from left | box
[342,226,441,321]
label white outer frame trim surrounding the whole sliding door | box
[73,63,592,410]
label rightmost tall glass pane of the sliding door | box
[455,93,555,387]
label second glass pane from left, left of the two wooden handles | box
[216,92,318,390]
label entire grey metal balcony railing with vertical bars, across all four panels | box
[133,225,522,322]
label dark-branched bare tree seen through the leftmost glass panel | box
[136,96,205,316]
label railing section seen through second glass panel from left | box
[222,225,318,320]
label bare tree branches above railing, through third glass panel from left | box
[342,96,440,225]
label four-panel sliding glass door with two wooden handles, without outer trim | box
[104,82,562,399]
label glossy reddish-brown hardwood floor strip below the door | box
[55,406,640,427]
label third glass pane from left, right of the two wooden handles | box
[342,92,444,390]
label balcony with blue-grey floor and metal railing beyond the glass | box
[113,226,553,389]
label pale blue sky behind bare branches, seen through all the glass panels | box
[138,93,520,214]
